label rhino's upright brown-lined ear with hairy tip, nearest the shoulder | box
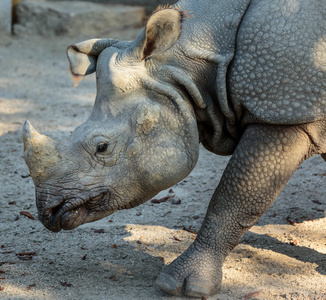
[139,7,185,60]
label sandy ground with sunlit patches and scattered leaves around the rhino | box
[0,30,326,300]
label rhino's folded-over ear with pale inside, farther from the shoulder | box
[66,39,119,81]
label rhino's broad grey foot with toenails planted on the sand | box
[156,245,222,297]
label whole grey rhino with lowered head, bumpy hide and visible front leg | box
[24,0,326,296]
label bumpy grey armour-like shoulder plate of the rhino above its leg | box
[228,0,326,124]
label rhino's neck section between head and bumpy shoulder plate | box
[168,0,251,155]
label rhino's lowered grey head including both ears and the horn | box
[23,8,199,232]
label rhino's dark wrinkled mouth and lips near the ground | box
[39,191,110,232]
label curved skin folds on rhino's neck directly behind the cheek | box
[149,65,236,155]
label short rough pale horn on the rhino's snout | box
[23,121,62,183]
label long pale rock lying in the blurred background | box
[14,0,146,36]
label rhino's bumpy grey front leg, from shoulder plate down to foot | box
[156,125,312,297]
